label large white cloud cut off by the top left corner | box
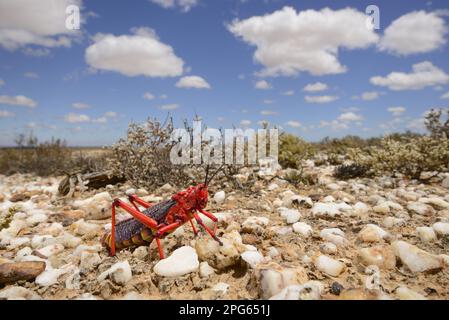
[0,0,83,50]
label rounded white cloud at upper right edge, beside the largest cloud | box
[379,11,448,55]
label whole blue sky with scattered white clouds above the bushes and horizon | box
[0,0,449,146]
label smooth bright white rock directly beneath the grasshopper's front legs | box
[153,246,199,277]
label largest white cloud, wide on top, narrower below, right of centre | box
[228,7,379,76]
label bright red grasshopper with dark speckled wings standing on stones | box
[102,167,222,259]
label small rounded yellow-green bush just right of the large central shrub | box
[279,133,315,169]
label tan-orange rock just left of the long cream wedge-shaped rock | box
[358,245,396,270]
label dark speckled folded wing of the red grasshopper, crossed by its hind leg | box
[115,199,176,242]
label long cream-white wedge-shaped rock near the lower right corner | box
[391,241,443,272]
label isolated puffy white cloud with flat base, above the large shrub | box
[85,28,184,77]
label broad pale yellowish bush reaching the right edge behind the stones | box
[348,136,449,178]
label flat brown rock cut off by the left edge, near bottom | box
[0,261,46,284]
